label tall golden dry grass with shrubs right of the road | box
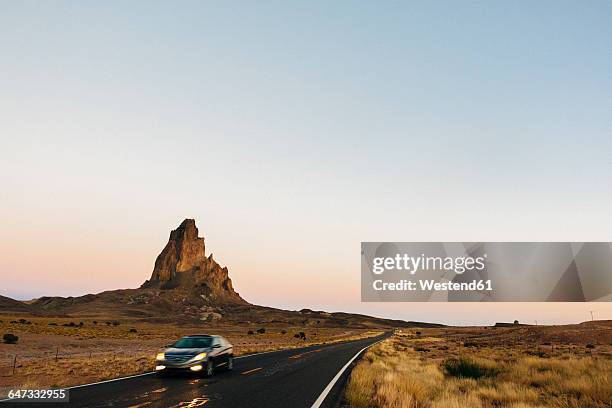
[345,329,612,408]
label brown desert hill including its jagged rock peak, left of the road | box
[0,219,442,328]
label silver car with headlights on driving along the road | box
[155,334,234,376]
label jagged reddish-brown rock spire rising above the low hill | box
[142,219,247,304]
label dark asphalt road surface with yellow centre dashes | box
[7,334,389,408]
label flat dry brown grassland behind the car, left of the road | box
[0,315,381,388]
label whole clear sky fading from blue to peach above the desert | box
[0,0,612,324]
